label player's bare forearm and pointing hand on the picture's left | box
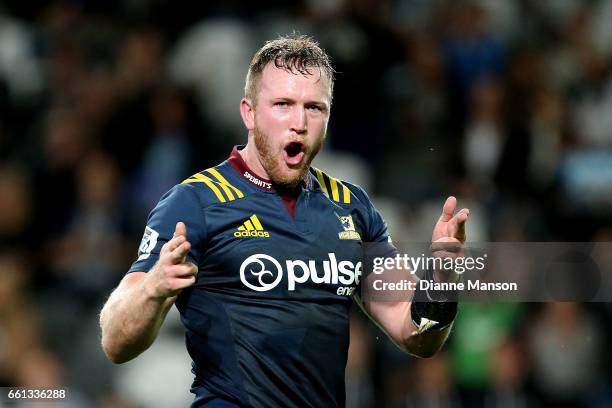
[100,222,198,364]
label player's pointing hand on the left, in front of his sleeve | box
[145,222,198,299]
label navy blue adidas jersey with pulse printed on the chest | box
[130,149,388,407]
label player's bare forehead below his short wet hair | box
[260,63,331,102]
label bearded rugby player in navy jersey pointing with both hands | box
[100,35,468,407]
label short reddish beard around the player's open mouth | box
[253,125,325,191]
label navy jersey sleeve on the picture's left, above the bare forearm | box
[128,184,206,273]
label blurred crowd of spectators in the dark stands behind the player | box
[0,0,612,408]
